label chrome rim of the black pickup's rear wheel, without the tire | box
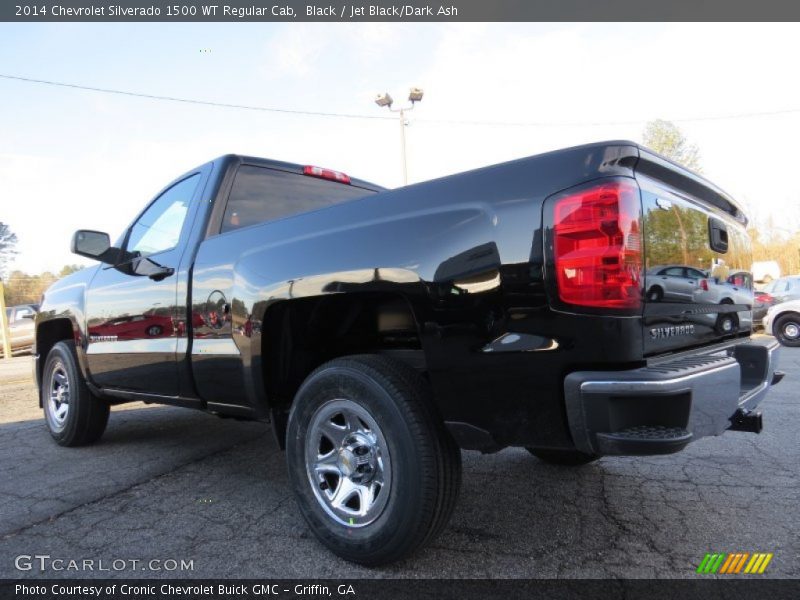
[305,399,392,527]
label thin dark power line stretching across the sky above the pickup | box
[0,73,800,127]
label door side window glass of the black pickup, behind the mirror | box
[126,174,200,256]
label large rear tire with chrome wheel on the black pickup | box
[286,355,461,566]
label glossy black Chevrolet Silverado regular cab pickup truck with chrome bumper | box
[35,141,782,565]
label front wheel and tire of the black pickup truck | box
[39,342,109,446]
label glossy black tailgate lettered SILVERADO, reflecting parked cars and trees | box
[636,149,753,356]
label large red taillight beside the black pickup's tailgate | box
[553,181,642,308]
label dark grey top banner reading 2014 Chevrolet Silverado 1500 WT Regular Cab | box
[0,0,800,22]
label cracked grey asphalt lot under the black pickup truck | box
[0,348,800,578]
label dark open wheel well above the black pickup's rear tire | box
[261,293,425,419]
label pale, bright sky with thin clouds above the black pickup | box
[0,23,800,273]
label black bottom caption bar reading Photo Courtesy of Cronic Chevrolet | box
[0,576,799,600]
